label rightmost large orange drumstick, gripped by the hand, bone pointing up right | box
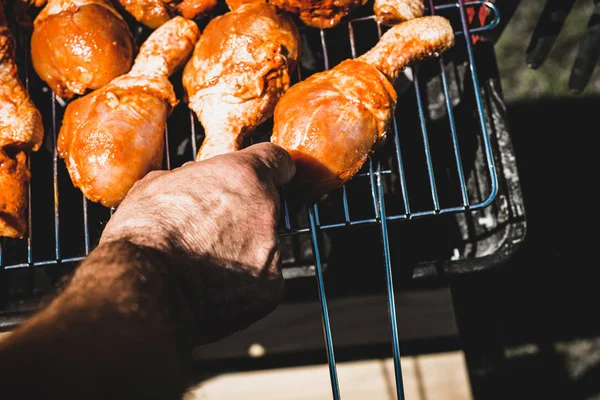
[271,16,454,201]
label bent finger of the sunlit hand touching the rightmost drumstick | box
[240,143,296,185]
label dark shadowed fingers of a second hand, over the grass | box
[526,0,600,94]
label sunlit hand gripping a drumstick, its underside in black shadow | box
[100,143,295,342]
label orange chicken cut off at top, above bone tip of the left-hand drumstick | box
[114,0,217,29]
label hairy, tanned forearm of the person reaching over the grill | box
[0,241,191,399]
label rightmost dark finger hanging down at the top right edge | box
[569,2,600,94]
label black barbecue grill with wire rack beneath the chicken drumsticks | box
[0,1,525,399]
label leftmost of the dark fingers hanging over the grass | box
[525,0,575,69]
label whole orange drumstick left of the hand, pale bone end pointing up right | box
[58,17,199,207]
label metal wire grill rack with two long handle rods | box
[0,0,499,399]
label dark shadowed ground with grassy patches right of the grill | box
[446,0,600,399]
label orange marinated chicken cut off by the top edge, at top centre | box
[226,0,367,29]
